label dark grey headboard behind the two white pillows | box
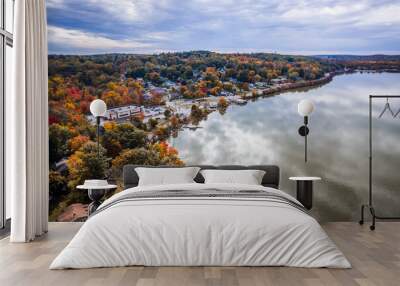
[123,165,280,189]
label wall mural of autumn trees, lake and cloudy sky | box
[46,0,400,221]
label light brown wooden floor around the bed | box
[0,222,400,286]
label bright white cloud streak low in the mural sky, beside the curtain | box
[48,26,151,51]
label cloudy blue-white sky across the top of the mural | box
[47,0,400,54]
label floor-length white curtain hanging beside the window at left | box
[6,0,49,242]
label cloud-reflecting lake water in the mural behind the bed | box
[170,73,400,221]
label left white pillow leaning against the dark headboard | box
[135,167,200,186]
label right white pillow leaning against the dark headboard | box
[200,170,265,185]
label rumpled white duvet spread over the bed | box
[50,184,351,269]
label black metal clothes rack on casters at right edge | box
[359,95,400,230]
